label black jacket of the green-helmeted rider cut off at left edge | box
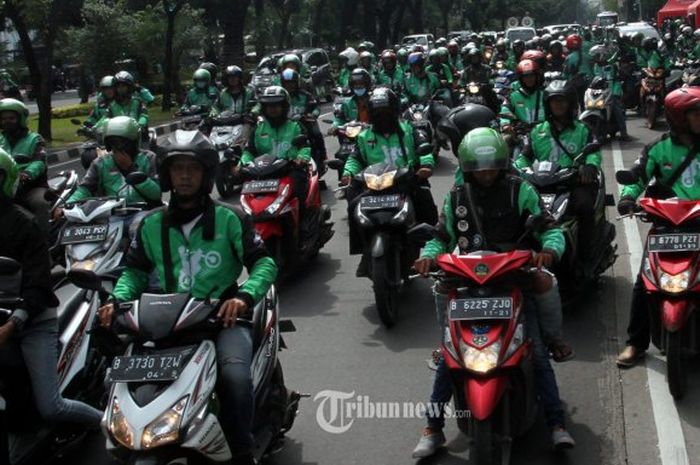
[0,200,58,320]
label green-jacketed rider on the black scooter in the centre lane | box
[340,87,437,277]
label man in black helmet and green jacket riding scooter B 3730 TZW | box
[99,130,277,464]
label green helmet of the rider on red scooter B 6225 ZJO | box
[457,128,508,173]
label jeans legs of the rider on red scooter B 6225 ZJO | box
[426,292,564,429]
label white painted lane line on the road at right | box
[612,141,690,465]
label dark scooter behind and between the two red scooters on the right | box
[521,143,617,300]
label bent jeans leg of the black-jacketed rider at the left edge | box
[19,318,102,428]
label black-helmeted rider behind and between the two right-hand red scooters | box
[513,81,601,280]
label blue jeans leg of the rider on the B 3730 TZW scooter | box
[216,325,255,454]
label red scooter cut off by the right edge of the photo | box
[616,171,700,400]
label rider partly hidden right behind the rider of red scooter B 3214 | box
[281,69,326,173]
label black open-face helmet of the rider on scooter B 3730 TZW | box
[158,129,219,195]
